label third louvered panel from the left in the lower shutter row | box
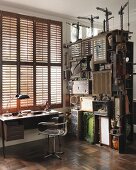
[36,66,48,105]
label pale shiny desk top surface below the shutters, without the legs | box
[0,110,61,122]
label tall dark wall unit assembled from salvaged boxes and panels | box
[66,30,133,153]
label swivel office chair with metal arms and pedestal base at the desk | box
[38,115,67,159]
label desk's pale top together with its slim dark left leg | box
[0,110,61,158]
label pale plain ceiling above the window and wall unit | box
[0,0,136,25]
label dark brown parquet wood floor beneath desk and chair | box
[0,137,136,170]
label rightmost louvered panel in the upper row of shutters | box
[50,24,62,63]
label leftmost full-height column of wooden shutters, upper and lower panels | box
[1,13,17,111]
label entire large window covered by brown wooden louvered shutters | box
[0,11,62,112]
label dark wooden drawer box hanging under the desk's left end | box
[4,121,24,141]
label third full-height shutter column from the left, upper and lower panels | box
[36,20,49,106]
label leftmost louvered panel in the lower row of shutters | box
[2,65,17,110]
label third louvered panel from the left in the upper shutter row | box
[36,21,48,63]
